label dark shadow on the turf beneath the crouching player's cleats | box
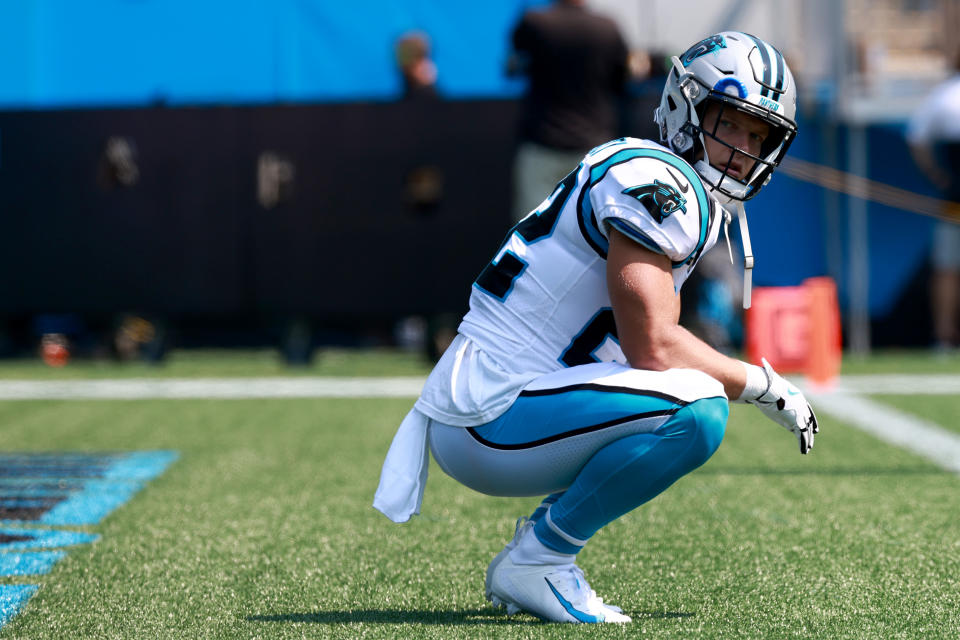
[247,608,695,626]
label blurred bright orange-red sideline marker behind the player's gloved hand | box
[744,277,843,386]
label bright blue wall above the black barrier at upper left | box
[0,0,545,108]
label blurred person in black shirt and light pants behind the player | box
[507,0,629,221]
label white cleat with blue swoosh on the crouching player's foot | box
[488,554,631,623]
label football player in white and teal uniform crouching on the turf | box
[374,32,817,622]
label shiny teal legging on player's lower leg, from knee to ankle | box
[534,398,729,553]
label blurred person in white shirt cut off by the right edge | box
[907,53,960,352]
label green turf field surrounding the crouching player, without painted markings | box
[0,353,960,639]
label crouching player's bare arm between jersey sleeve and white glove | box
[607,230,746,399]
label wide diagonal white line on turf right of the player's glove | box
[807,391,960,473]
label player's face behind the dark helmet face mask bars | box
[703,102,770,182]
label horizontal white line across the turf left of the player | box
[0,377,424,400]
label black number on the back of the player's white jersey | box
[474,167,580,300]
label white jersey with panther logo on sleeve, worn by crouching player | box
[417,138,723,426]
